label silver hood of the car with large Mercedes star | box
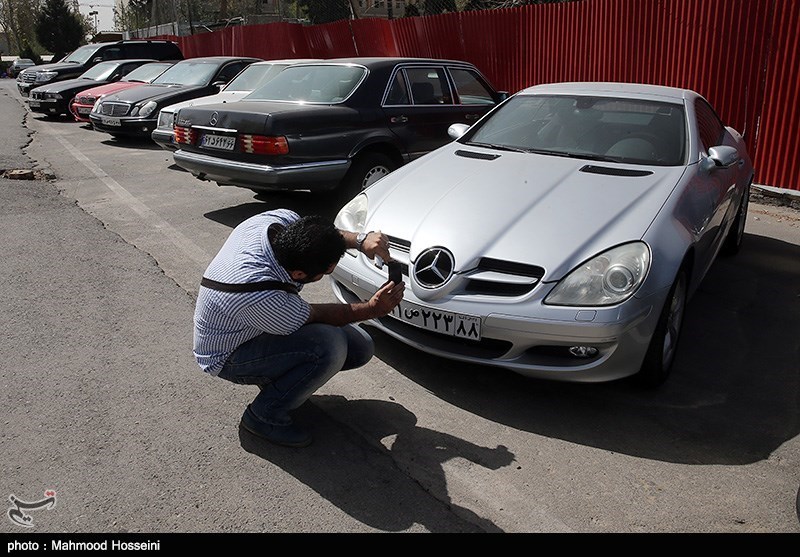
[366,143,685,281]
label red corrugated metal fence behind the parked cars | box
[153,0,800,190]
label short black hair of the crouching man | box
[271,215,347,277]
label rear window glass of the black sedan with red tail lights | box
[245,65,367,104]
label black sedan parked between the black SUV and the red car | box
[27,59,155,116]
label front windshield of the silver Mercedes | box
[461,95,686,166]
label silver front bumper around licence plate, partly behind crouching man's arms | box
[331,254,668,382]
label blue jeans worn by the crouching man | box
[219,323,375,425]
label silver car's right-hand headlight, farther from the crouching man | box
[544,242,650,306]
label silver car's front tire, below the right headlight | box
[635,267,689,387]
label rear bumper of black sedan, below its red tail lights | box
[173,149,350,191]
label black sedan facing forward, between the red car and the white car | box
[89,56,261,138]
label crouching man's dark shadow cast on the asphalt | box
[239,395,506,532]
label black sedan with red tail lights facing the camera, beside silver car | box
[173,57,507,196]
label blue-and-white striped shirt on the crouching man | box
[194,209,311,375]
